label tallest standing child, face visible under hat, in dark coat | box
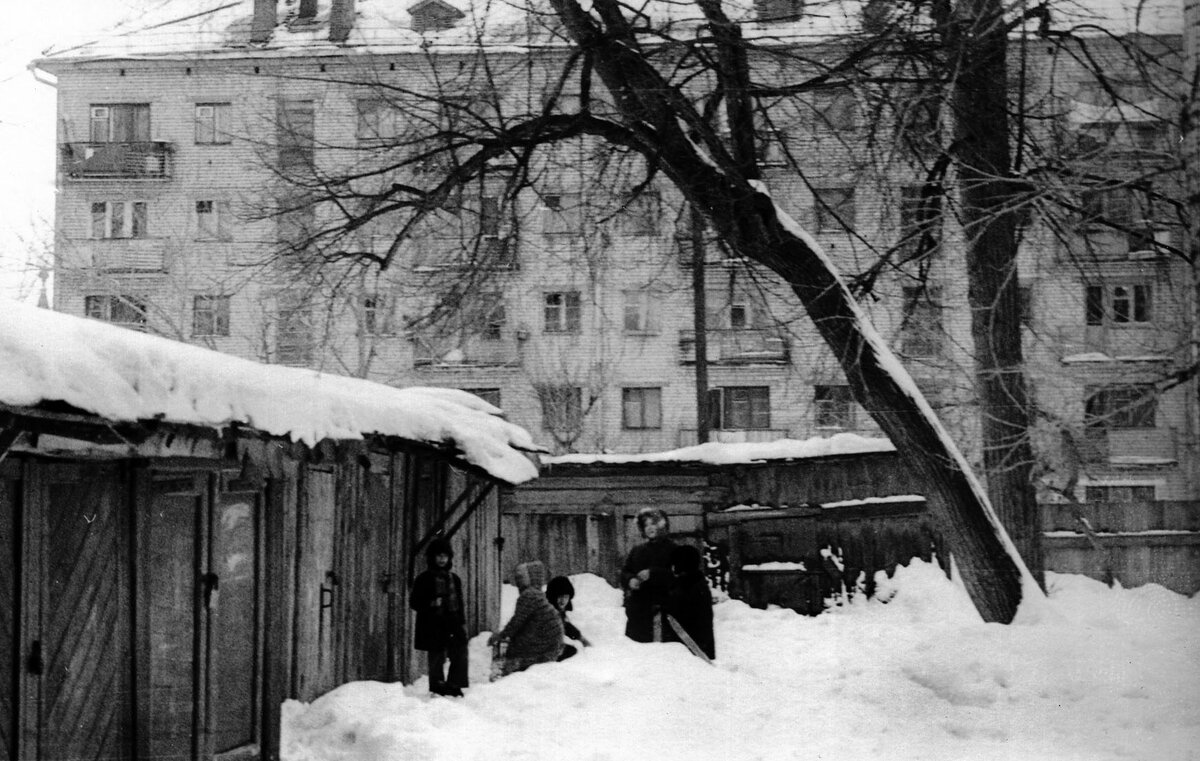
[620,508,676,642]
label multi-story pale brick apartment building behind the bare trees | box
[37,0,1200,499]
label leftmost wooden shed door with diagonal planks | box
[23,465,133,761]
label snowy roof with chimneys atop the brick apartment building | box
[40,0,1183,65]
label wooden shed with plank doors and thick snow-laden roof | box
[0,302,535,761]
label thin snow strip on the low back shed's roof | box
[541,433,895,465]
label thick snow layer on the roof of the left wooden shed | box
[0,298,541,484]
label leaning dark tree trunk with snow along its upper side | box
[551,0,1032,623]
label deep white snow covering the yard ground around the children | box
[282,561,1200,761]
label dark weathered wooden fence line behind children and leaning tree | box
[500,453,1200,612]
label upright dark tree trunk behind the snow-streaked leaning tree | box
[947,0,1044,583]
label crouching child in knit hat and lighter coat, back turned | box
[487,561,563,676]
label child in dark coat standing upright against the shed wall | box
[409,538,468,697]
